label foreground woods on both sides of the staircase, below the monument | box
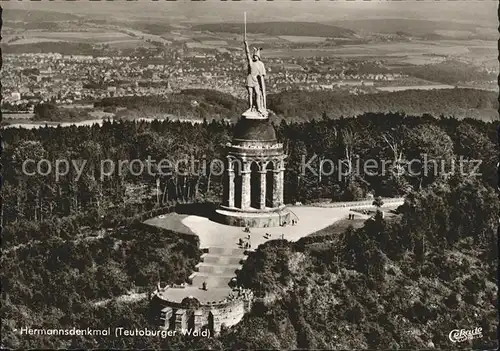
[2,177,500,350]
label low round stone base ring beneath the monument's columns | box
[213,207,292,228]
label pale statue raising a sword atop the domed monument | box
[243,13,268,118]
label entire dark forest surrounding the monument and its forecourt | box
[1,107,499,349]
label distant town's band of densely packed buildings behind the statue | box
[2,44,494,116]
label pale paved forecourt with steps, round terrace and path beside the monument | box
[150,201,404,303]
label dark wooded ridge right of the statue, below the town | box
[267,89,498,120]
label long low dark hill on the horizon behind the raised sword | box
[192,22,355,38]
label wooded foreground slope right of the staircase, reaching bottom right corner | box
[229,179,499,350]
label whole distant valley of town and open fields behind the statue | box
[1,10,498,120]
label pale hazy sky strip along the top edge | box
[2,0,498,26]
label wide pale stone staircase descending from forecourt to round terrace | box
[189,247,246,289]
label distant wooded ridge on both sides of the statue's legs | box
[95,88,498,123]
